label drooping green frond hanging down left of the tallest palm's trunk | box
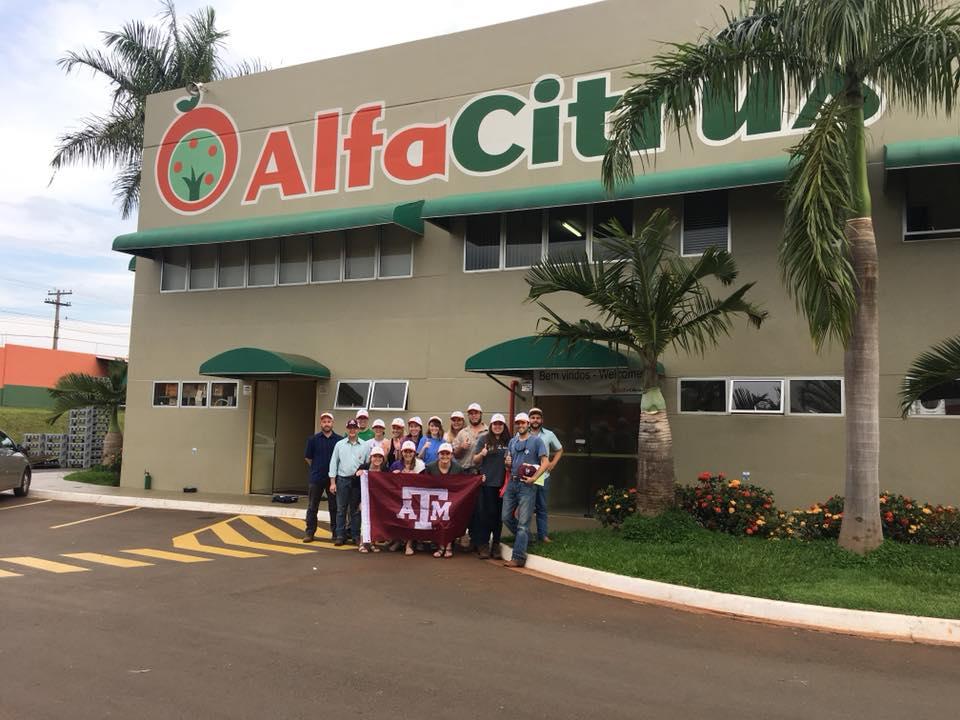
[780,96,857,348]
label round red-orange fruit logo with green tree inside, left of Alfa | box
[154,98,240,215]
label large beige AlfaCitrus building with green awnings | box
[114,0,960,512]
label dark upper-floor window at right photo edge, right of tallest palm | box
[907,165,960,240]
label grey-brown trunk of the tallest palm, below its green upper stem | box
[840,216,883,555]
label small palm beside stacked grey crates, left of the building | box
[47,360,127,465]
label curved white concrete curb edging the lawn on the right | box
[501,545,960,647]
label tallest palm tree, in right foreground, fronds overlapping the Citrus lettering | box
[602,0,960,553]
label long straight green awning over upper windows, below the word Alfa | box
[113,200,423,255]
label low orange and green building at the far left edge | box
[0,344,112,408]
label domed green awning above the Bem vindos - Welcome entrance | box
[463,335,664,375]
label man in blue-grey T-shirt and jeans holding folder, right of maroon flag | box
[502,413,547,567]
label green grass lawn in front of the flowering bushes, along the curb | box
[534,513,960,618]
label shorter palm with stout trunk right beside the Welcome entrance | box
[525,210,767,514]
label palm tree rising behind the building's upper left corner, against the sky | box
[50,0,264,218]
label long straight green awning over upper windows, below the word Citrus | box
[423,154,790,220]
